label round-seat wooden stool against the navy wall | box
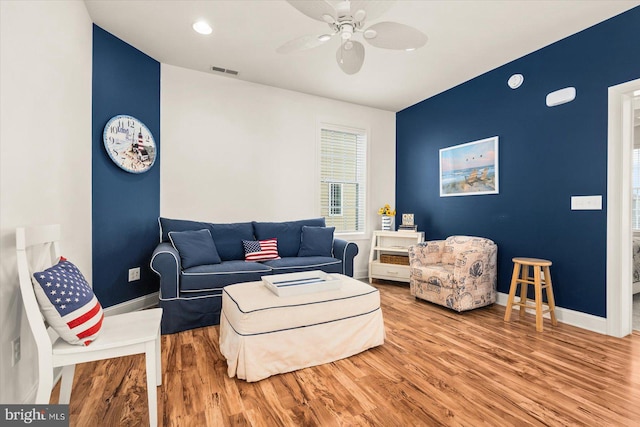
[504,258,558,332]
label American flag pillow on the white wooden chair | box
[33,257,104,345]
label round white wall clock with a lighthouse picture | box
[102,114,157,173]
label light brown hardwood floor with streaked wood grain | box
[52,282,640,427]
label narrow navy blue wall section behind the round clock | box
[92,25,160,307]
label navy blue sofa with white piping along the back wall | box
[151,218,358,334]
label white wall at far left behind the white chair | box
[0,1,92,403]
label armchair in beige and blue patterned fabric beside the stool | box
[409,236,498,312]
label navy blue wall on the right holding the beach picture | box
[396,7,640,317]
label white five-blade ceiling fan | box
[277,0,427,74]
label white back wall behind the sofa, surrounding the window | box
[160,64,396,277]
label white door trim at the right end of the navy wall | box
[607,79,640,337]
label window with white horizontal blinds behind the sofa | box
[320,125,367,233]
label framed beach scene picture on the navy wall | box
[440,136,498,197]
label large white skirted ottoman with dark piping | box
[220,275,385,381]
